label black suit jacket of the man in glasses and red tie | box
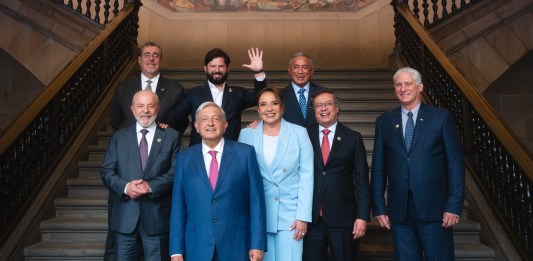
[307,122,370,228]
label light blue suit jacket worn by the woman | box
[239,119,313,233]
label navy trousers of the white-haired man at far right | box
[392,190,454,261]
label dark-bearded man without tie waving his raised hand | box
[169,48,266,146]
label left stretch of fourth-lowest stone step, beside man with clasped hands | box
[67,176,108,198]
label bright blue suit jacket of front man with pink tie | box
[170,140,267,261]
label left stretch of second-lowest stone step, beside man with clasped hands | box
[41,217,107,242]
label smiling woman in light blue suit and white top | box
[239,88,313,261]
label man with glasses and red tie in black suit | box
[303,90,370,261]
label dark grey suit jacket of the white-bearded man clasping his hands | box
[100,125,180,234]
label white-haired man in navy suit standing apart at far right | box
[371,67,465,261]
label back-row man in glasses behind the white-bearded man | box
[111,42,184,130]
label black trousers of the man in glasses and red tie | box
[303,218,359,261]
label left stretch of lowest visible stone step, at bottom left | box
[24,241,105,261]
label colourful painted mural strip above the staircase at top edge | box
[152,0,376,12]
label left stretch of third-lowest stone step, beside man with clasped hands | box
[54,197,107,218]
